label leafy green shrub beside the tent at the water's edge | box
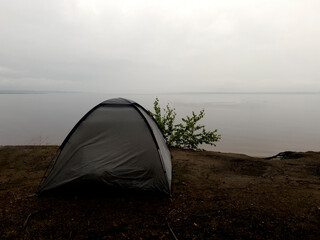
[149,98,221,150]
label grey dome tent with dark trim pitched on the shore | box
[39,98,172,195]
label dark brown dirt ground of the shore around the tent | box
[0,146,320,239]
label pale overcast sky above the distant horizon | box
[0,0,320,93]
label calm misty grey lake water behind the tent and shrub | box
[0,93,320,156]
